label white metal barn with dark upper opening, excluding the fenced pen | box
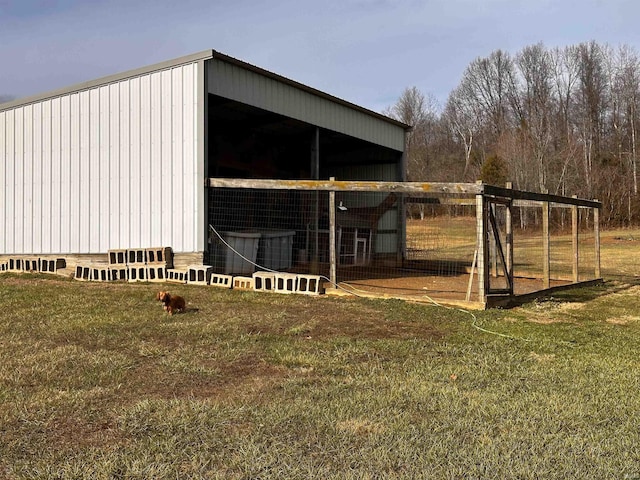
[0,50,408,265]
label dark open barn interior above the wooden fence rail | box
[207,94,402,180]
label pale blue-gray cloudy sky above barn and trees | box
[0,0,640,111]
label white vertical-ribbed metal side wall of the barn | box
[0,62,204,254]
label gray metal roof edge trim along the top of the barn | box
[0,50,411,130]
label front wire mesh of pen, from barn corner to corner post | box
[208,188,477,300]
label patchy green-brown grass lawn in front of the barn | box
[0,232,640,479]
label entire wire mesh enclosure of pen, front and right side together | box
[207,181,596,308]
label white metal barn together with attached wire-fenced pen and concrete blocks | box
[0,50,600,308]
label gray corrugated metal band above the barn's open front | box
[207,58,405,151]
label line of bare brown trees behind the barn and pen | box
[384,41,640,226]
